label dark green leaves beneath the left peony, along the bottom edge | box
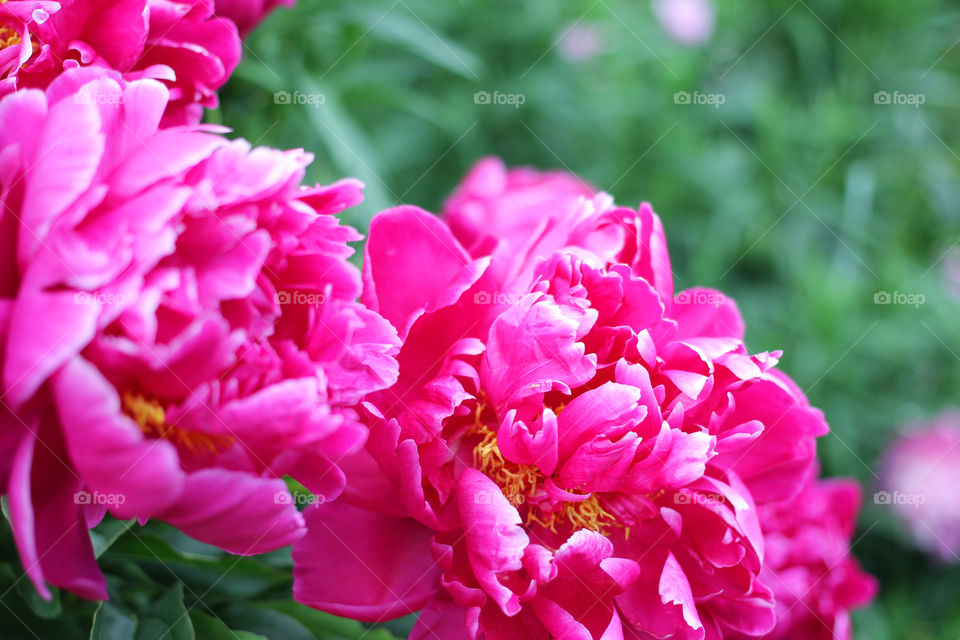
[0,517,404,640]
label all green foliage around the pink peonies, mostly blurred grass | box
[0,0,960,640]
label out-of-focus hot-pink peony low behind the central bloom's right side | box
[760,479,877,640]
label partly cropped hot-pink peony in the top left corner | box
[0,0,240,124]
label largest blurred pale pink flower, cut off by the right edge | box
[874,409,960,562]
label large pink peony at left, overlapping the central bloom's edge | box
[0,68,398,598]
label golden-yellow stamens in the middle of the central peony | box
[471,403,629,535]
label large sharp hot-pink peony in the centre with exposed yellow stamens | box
[294,159,872,640]
